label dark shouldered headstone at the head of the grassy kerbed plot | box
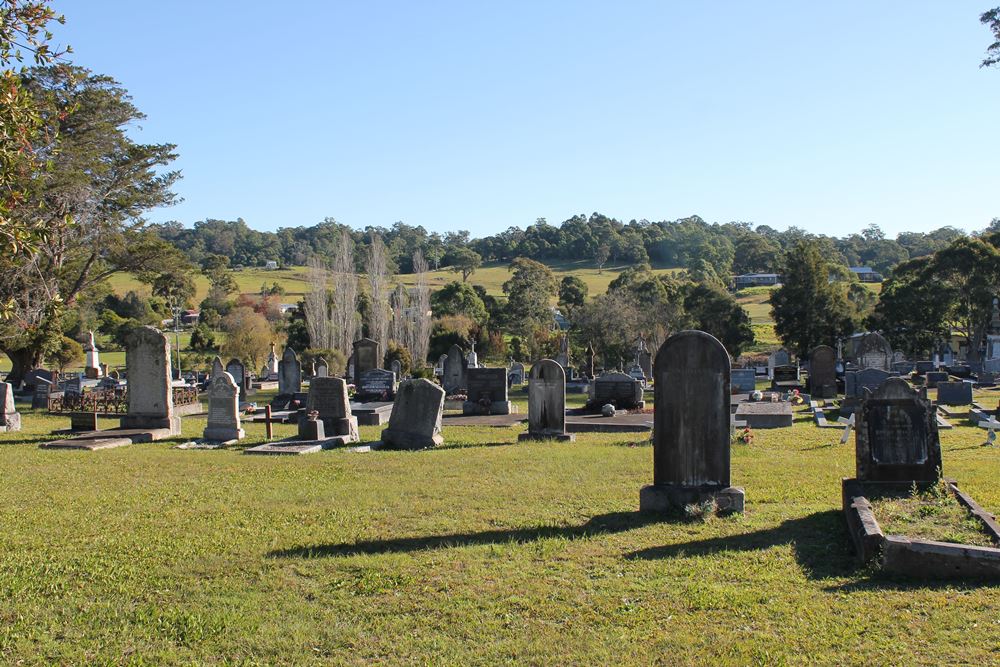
[855,378,941,482]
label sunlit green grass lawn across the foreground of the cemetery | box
[0,410,1000,665]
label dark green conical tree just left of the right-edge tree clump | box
[770,239,859,357]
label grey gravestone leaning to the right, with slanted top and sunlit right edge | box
[382,378,445,449]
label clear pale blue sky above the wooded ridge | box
[56,0,1000,236]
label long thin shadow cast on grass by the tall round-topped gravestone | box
[268,512,681,558]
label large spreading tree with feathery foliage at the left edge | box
[0,67,178,383]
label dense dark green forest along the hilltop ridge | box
[153,213,1000,277]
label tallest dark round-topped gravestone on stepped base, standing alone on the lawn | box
[639,331,744,512]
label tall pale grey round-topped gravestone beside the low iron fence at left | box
[121,326,181,434]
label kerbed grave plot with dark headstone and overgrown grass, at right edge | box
[843,378,1000,578]
